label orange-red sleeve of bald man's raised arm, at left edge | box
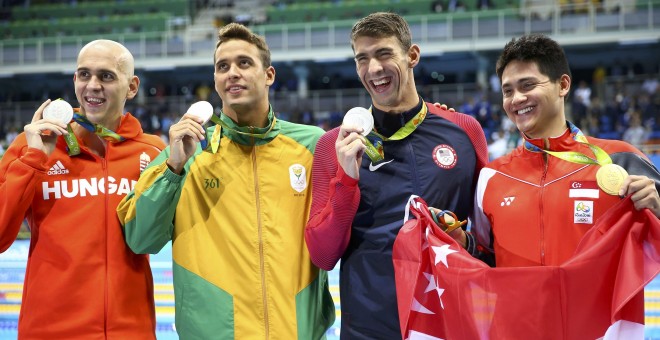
[0,134,48,252]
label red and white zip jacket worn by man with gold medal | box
[472,123,660,267]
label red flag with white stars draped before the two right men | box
[393,196,660,340]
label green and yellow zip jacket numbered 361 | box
[117,111,335,339]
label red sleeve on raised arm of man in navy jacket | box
[305,128,360,270]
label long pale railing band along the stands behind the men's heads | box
[0,0,660,76]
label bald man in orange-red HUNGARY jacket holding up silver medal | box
[0,40,164,340]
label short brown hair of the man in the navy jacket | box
[351,12,412,51]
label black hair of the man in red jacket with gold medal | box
[495,34,571,82]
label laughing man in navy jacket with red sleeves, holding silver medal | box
[305,12,488,339]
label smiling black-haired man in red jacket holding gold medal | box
[452,34,660,333]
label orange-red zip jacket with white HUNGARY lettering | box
[0,113,164,340]
